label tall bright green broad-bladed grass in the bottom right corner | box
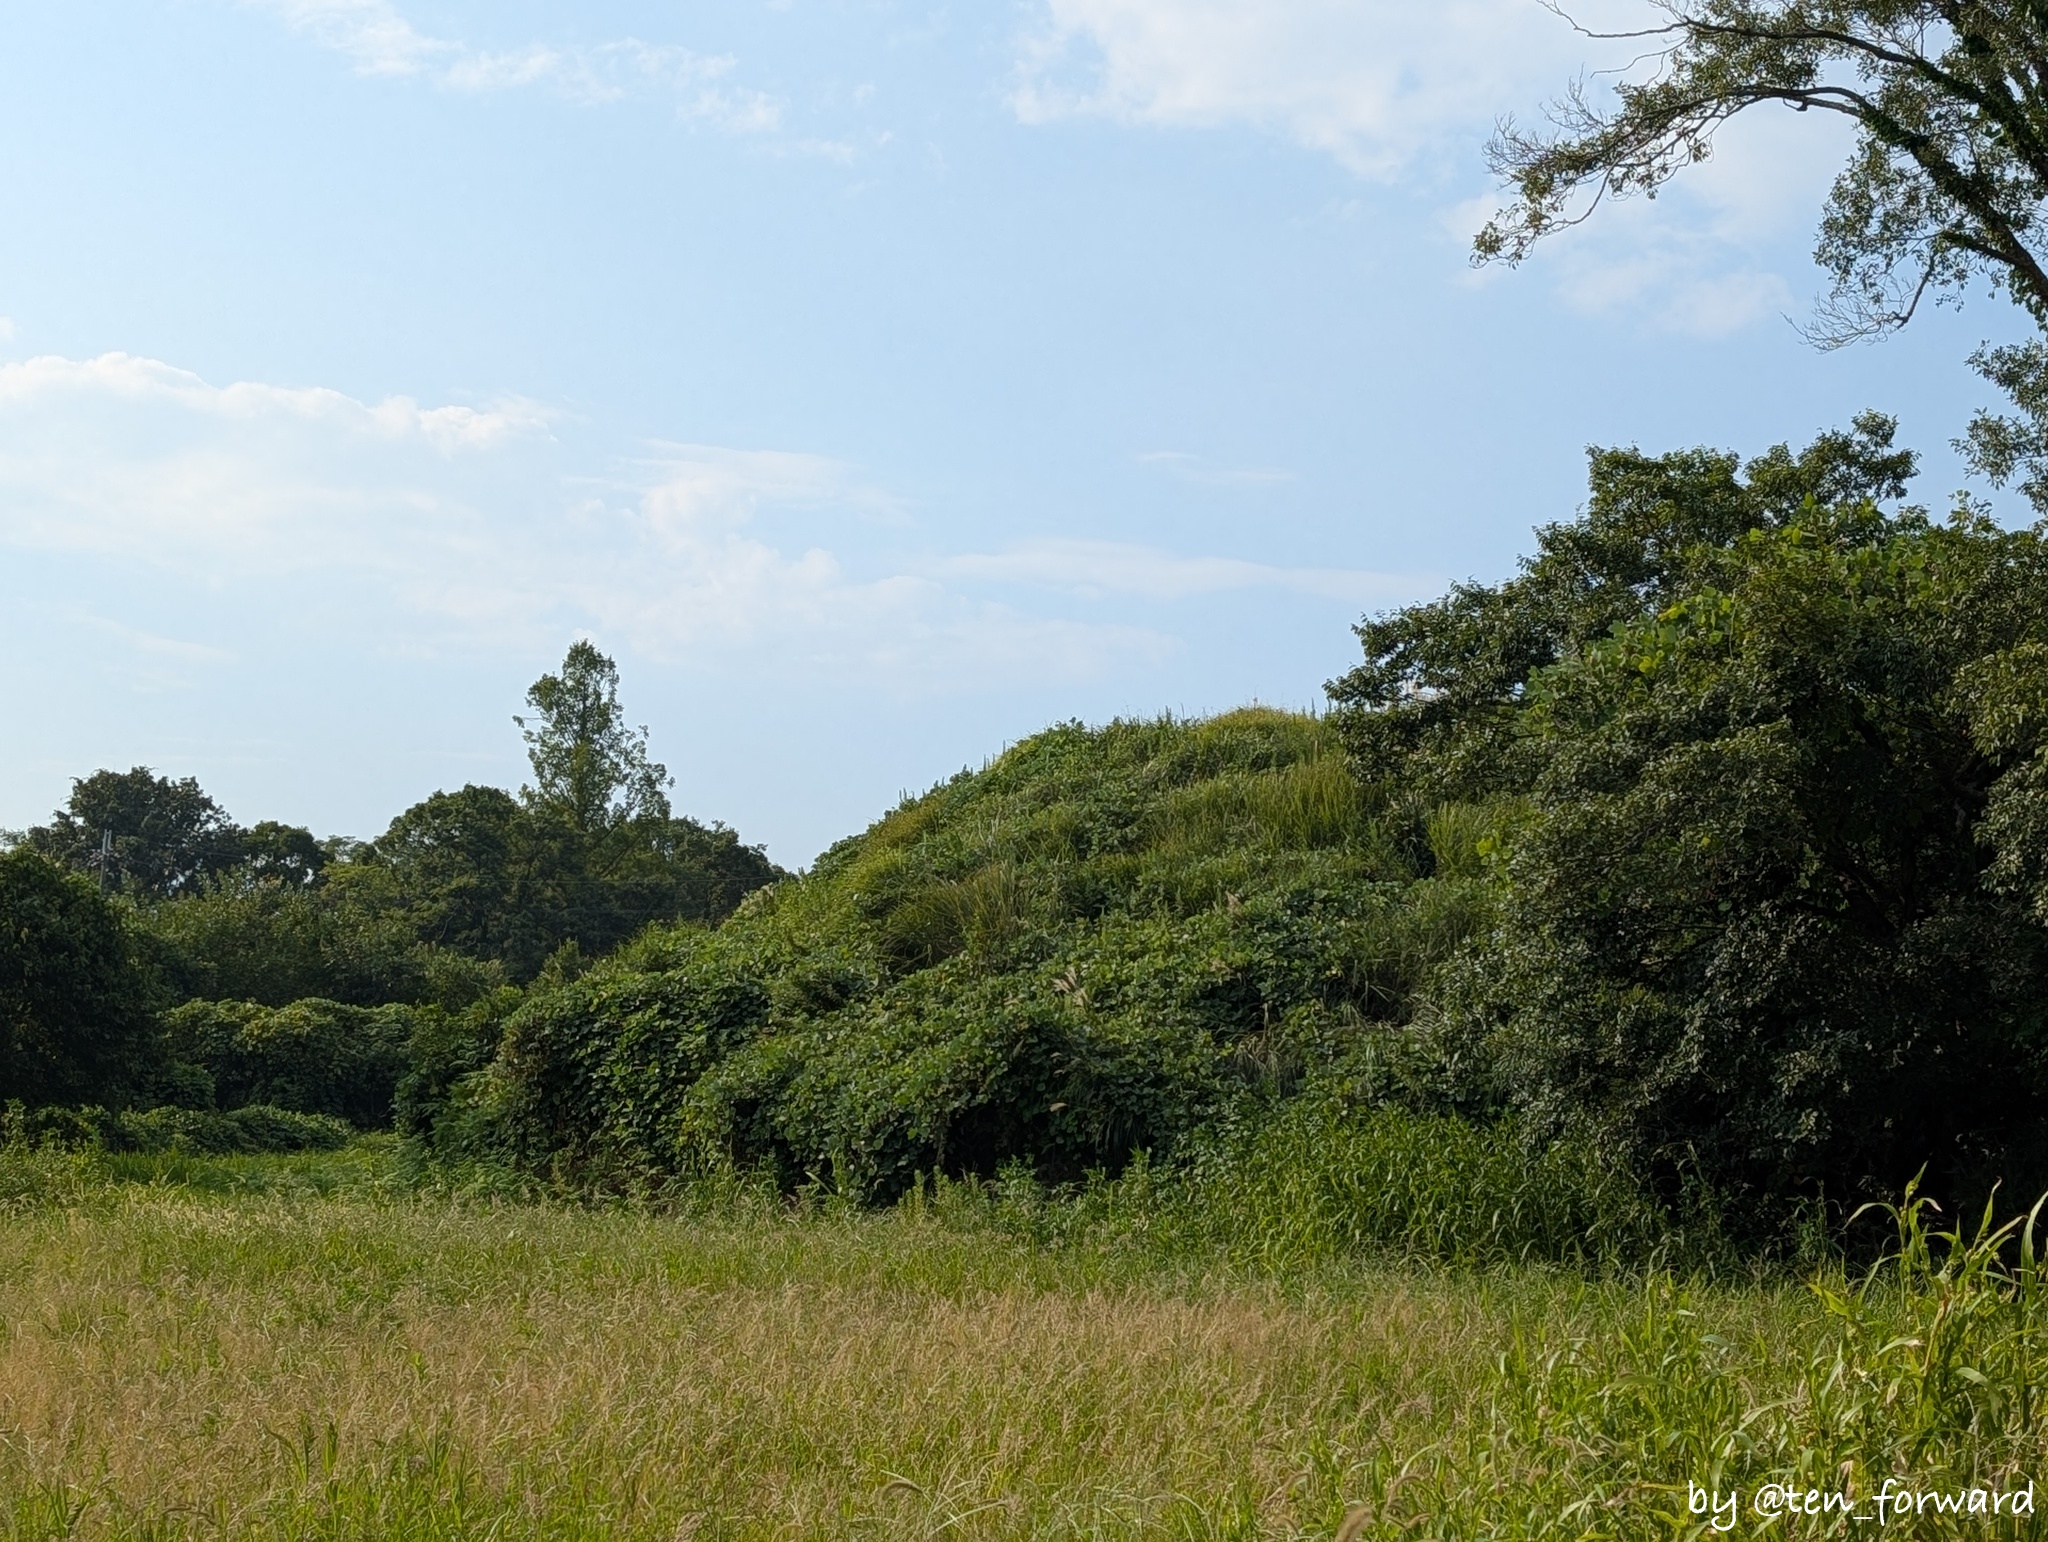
[1352,1194,2048,1542]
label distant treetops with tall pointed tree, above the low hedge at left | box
[23,641,780,1008]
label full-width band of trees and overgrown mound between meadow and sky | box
[12,418,2048,1247]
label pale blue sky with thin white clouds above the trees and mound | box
[0,0,2011,864]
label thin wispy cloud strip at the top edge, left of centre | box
[244,0,782,133]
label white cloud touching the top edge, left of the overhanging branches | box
[1012,0,1640,176]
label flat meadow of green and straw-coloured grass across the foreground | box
[0,1143,2042,1540]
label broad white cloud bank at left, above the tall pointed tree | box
[0,354,1178,692]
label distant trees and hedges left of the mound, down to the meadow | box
[0,643,780,1126]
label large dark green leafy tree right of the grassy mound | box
[1331,420,2048,1210]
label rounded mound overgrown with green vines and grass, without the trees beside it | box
[440,709,1483,1198]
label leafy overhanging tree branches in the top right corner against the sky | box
[1477,0,2048,508]
